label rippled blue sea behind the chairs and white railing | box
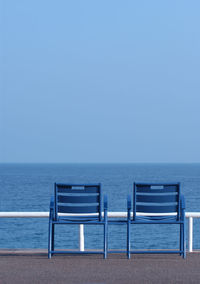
[0,164,200,249]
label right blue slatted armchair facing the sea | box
[127,183,186,258]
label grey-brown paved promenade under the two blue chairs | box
[0,250,200,284]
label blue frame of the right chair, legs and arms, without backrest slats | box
[127,183,186,258]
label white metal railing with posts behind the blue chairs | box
[0,212,200,252]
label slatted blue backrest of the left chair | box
[54,183,102,220]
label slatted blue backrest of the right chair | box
[133,183,180,220]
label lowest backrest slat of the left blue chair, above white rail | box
[58,205,99,214]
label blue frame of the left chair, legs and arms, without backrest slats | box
[48,183,108,258]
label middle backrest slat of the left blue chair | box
[58,195,100,203]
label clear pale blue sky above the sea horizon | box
[0,0,200,162]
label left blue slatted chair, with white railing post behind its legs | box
[48,183,108,258]
